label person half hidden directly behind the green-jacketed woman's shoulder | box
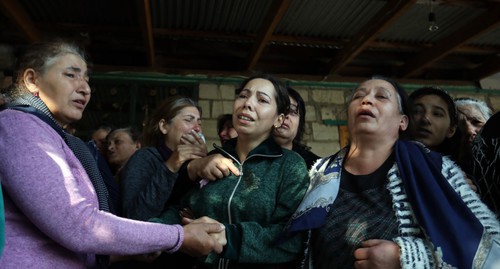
[273,87,320,169]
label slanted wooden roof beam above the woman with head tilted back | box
[327,0,417,75]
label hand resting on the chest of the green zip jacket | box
[188,153,240,181]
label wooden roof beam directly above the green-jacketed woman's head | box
[246,0,292,70]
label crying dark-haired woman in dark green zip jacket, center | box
[154,72,309,268]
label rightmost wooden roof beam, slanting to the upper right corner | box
[399,5,500,78]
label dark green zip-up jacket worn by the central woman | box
[155,138,309,268]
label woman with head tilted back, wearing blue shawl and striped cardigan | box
[285,77,500,269]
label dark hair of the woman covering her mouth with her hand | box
[141,96,201,147]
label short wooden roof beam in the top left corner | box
[0,0,41,43]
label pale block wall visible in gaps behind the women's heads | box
[199,82,500,157]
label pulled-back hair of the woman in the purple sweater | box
[9,40,87,98]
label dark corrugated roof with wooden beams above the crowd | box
[0,0,500,80]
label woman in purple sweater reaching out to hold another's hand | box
[0,42,222,268]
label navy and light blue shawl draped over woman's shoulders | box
[284,141,484,268]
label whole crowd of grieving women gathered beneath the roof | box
[0,41,500,268]
